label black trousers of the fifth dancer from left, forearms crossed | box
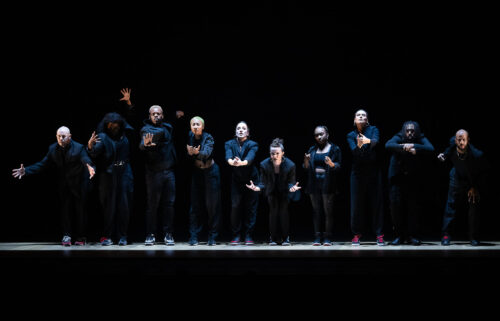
[231,179,259,236]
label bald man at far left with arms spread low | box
[12,126,95,246]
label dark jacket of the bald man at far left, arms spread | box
[25,140,95,186]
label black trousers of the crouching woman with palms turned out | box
[267,193,290,243]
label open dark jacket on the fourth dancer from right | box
[305,142,342,194]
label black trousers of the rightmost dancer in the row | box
[442,170,480,240]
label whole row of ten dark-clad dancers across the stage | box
[12,89,486,246]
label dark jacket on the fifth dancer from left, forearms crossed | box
[224,138,259,184]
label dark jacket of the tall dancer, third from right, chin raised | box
[347,125,380,172]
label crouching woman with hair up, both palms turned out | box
[246,138,302,246]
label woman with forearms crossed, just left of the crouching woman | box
[225,121,259,245]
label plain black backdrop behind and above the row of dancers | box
[0,2,500,242]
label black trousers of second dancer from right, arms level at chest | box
[389,175,422,238]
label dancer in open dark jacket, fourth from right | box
[304,126,342,246]
